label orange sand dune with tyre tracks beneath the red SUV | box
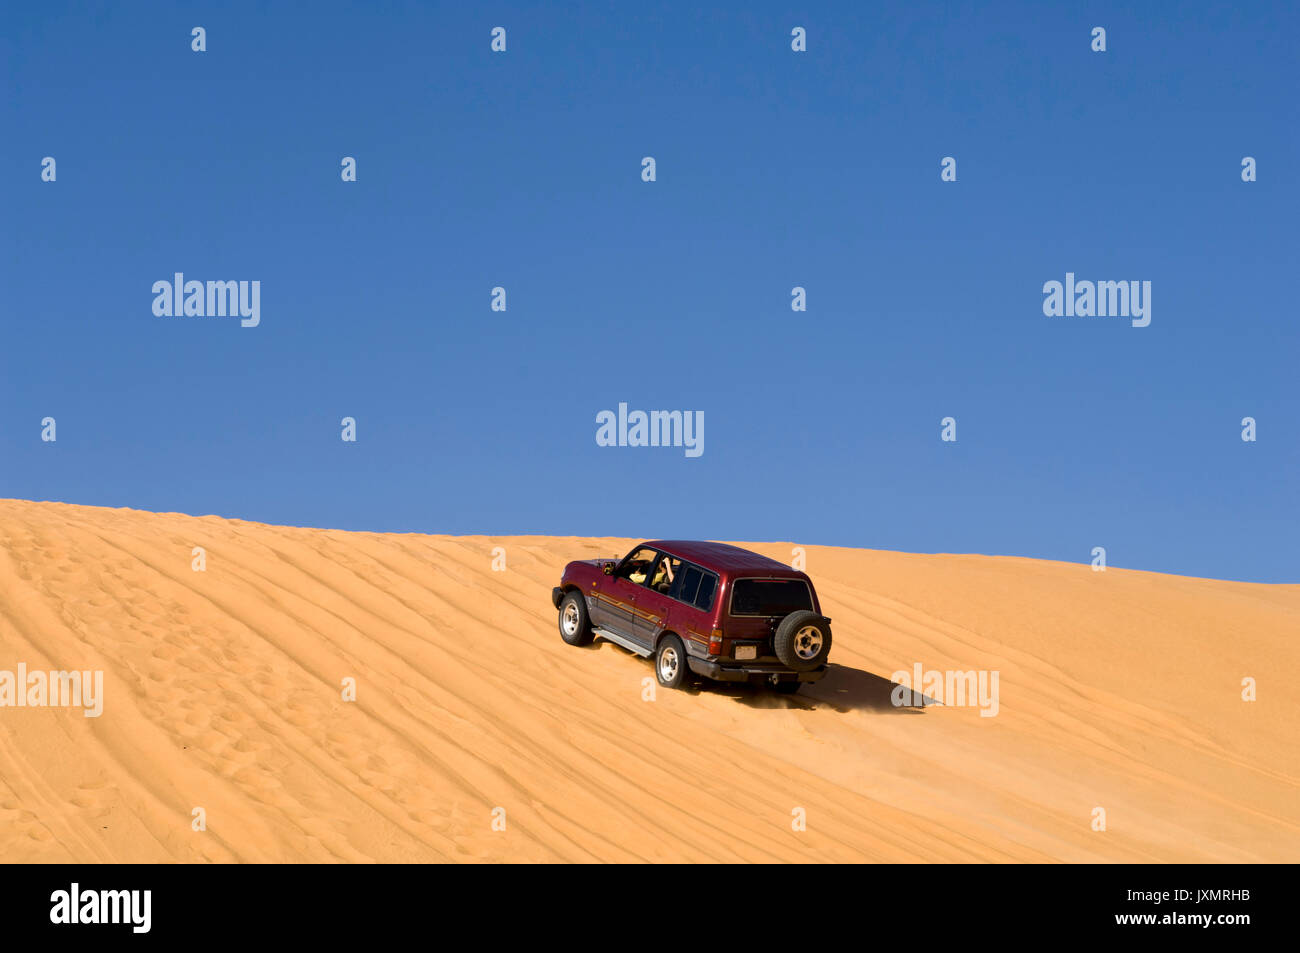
[0,501,1300,862]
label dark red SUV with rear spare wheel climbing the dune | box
[551,540,831,692]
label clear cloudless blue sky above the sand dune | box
[0,3,1300,582]
